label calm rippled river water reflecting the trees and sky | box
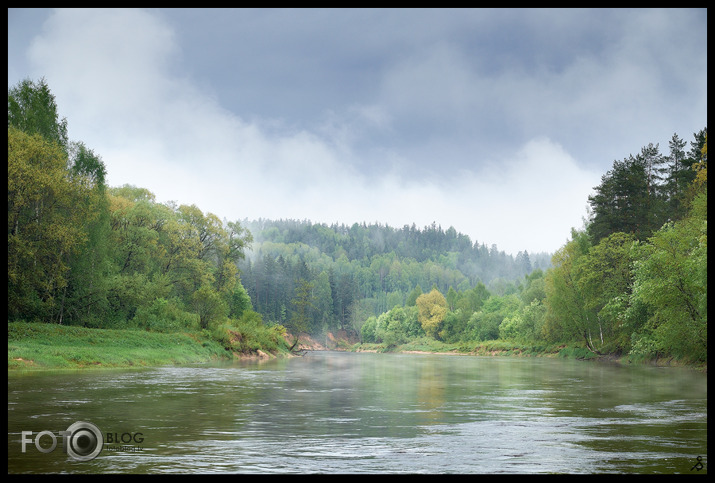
[8,352,707,474]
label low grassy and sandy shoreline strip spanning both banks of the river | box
[8,322,707,372]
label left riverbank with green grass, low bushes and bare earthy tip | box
[7,322,357,371]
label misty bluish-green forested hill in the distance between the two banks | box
[239,219,551,327]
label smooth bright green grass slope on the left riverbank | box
[7,322,290,370]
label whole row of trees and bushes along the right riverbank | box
[361,129,707,363]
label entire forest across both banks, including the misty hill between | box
[8,79,707,363]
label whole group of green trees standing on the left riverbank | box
[8,79,281,349]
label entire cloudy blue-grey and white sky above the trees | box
[8,9,707,255]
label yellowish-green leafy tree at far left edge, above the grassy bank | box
[8,127,95,322]
